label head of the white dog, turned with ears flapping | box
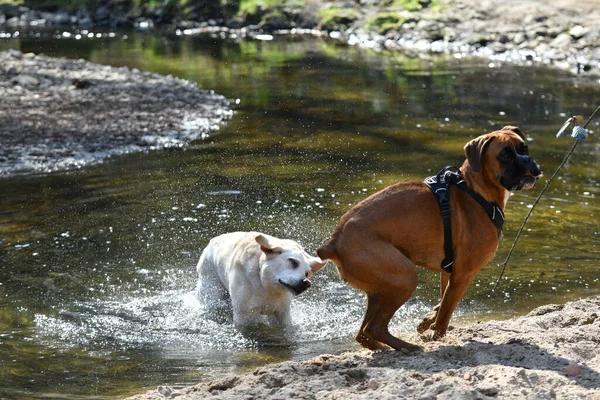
[256,234,326,295]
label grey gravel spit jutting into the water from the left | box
[0,50,232,176]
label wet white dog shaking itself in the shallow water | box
[196,232,325,326]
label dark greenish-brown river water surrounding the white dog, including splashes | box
[0,29,600,399]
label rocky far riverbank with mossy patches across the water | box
[0,0,600,75]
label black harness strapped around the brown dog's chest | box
[425,167,504,273]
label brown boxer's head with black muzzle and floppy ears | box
[465,126,542,192]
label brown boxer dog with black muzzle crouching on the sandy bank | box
[317,126,541,350]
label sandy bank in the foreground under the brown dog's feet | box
[129,296,600,400]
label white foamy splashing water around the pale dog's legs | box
[35,278,430,360]
